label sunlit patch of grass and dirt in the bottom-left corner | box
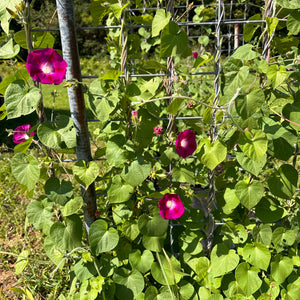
[0,151,68,300]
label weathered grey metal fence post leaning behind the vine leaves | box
[56,0,96,232]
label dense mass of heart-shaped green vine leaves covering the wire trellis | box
[0,0,300,300]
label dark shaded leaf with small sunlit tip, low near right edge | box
[255,196,288,223]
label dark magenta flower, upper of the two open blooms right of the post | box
[175,129,197,158]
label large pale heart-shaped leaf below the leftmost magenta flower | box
[11,153,40,191]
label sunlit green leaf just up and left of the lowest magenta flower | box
[121,155,151,187]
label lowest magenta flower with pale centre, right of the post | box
[158,193,184,220]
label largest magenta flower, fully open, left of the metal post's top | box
[26,48,68,85]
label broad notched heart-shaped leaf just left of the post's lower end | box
[50,215,82,251]
